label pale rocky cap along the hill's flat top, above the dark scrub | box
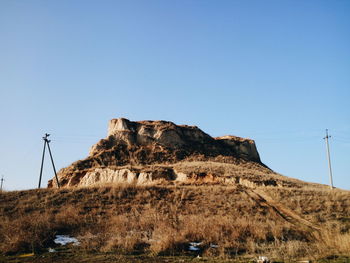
[90,118,260,162]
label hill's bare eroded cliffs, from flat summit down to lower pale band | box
[49,118,271,187]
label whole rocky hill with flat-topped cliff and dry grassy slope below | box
[0,119,350,263]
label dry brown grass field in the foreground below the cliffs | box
[0,185,350,263]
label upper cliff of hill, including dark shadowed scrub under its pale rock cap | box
[90,118,260,164]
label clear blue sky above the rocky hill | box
[0,0,350,190]
